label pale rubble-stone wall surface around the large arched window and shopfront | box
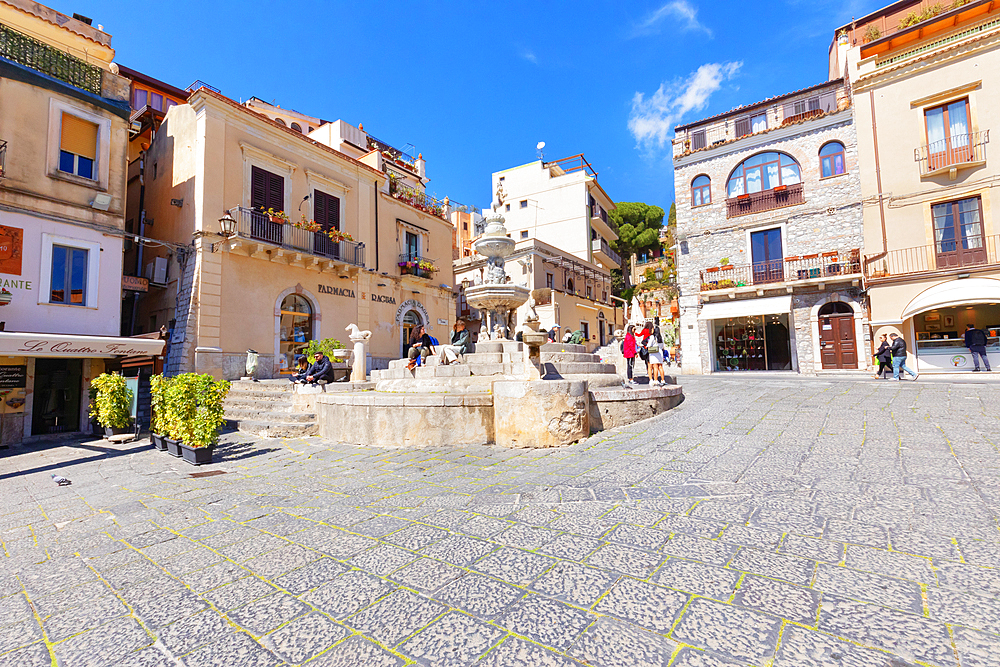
[674,109,865,373]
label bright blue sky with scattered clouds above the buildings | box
[74,0,887,209]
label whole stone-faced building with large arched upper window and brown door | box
[673,79,869,373]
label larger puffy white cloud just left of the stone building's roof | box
[628,62,743,148]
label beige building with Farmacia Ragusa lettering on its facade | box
[137,86,454,378]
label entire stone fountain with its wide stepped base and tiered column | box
[300,189,684,447]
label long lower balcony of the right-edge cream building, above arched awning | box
[864,235,1000,283]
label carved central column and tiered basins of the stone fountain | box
[465,211,531,340]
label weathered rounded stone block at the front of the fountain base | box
[493,380,590,448]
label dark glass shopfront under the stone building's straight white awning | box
[713,313,792,371]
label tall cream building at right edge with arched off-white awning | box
[830,0,1000,372]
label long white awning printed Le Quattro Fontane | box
[0,331,166,358]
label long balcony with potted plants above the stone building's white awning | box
[701,249,861,292]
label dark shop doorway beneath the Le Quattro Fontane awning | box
[31,359,83,435]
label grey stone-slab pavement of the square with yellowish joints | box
[0,378,1000,667]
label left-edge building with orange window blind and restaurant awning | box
[0,0,163,445]
